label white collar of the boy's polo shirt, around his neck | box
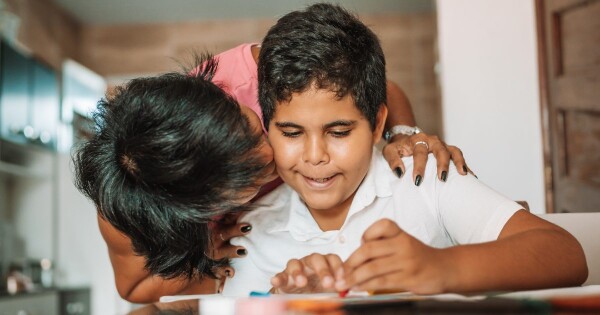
[269,148,394,242]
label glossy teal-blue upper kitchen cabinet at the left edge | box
[0,42,60,149]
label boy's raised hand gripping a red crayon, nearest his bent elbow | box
[335,219,452,294]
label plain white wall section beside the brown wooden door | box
[437,0,545,213]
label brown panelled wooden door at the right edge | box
[536,0,600,212]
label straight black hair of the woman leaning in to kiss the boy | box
[73,55,265,278]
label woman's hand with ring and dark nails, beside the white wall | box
[383,132,469,186]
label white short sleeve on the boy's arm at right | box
[436,164,523,245]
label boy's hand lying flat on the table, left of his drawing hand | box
[271,254,342,293]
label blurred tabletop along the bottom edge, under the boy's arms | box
[125,285,600,315]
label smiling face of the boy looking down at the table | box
[269,88,387,215]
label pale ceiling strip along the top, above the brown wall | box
[53,0,433,25]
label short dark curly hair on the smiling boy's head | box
[258,3,386,129]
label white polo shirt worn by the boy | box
[223,149,522,296]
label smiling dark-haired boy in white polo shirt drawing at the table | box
[223,4,587,296]
